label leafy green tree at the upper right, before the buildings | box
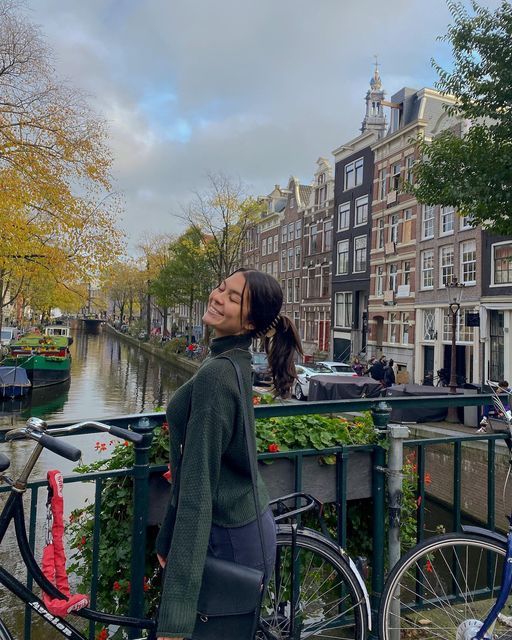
[411,0,512,235]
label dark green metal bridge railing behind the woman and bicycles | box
[0,394,503,640]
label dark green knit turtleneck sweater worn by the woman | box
[156,336,268,637]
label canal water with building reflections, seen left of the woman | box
[0,332,189,640]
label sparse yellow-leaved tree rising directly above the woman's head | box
[185,173,263,282]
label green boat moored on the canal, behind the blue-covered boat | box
[0,333,71,389]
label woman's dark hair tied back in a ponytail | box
[238,269,302,398]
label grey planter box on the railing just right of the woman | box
[259,451,372,502]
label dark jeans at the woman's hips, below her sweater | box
[208,509,276,584]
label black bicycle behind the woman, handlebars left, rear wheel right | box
[0,418,371,640]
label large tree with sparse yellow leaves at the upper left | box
[0,0,122,336]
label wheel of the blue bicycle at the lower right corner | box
[379,533,512,640]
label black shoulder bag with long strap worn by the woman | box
[164,356,265,640]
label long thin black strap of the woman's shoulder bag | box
[171,355,267,566]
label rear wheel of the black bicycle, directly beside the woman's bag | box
[257,525,368,640]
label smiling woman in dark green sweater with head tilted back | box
[157,269,302,640]
